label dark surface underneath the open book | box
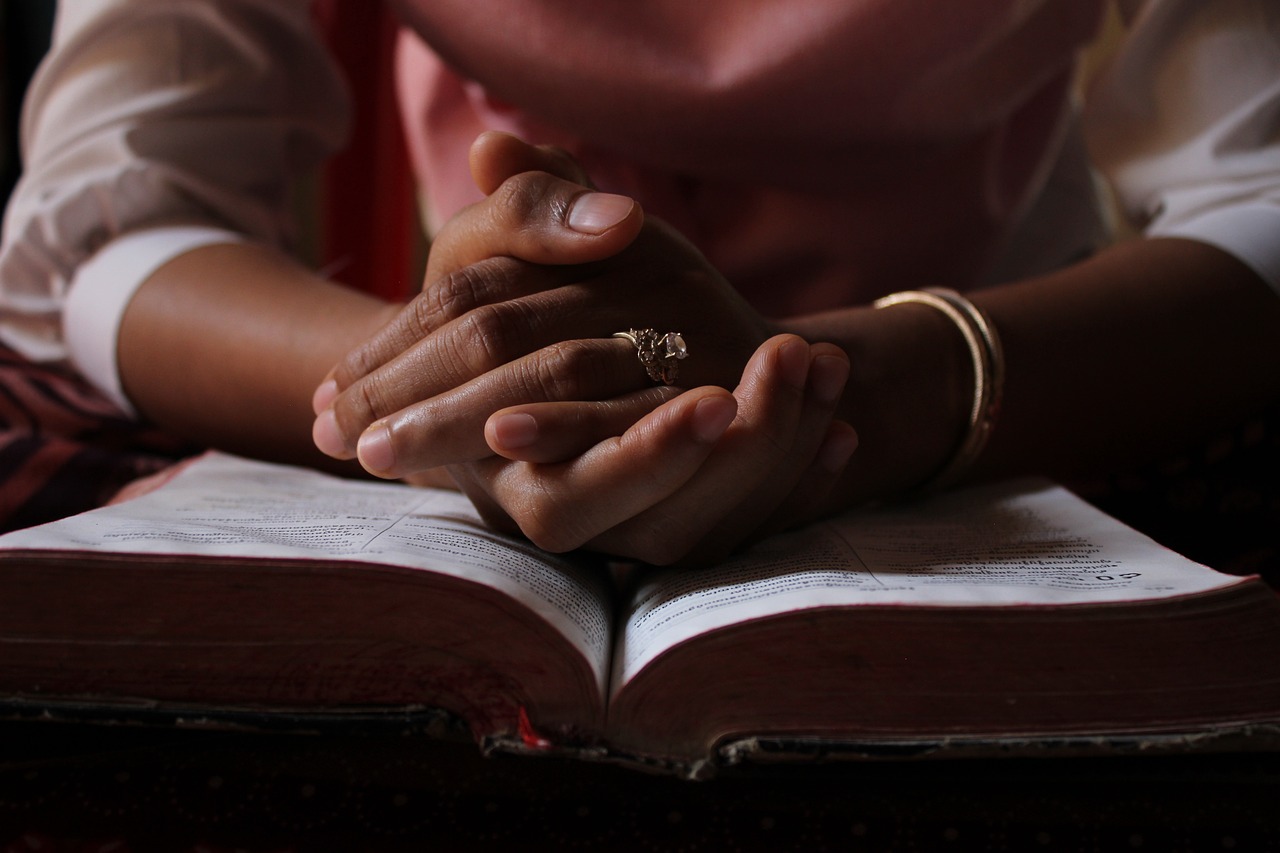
[0,721,1280,853]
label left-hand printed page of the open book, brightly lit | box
[0,453,612,690]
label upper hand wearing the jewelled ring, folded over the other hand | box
[314,134,774,476]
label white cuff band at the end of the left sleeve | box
[63,225,246,418]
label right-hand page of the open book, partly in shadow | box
[614,473,1239,692]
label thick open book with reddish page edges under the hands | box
[0,453,1280,775]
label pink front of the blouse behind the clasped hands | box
[398,0,1103,316]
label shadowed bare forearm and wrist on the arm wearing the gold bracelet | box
[788,240,1280,502]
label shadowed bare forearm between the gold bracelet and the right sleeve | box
[974,240,1280,476]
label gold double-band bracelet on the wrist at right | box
[873,287,1005,492]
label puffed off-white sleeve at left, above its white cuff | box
[0,0,348,368]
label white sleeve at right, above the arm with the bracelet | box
[1085,0,1280,292]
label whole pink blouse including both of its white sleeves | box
[0,0,1280,405]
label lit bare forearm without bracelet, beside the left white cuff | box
[118,243,394,465]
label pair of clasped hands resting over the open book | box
[314,133,856,564]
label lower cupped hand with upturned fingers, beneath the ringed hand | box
[449,334,858,565]
